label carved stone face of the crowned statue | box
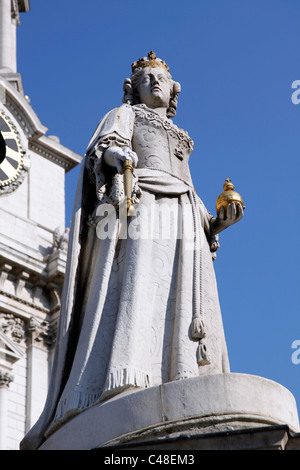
[137,67,171,108]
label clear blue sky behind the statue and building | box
[18,0,300,416]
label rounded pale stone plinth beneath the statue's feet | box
[40,373,299,450]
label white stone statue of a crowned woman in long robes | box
[21,52,243,449]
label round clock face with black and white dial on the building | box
[0,111,24,188]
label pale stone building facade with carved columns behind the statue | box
[0,0,81,450]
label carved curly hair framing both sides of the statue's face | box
[123,68,181,117]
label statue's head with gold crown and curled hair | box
[123,51,181,117]
